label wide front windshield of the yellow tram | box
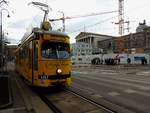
[41,41,70,59]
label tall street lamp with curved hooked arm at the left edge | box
[0,8,10,68]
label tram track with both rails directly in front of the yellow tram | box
[38,88,117,113]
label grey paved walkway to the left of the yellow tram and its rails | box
[0,62,53,113]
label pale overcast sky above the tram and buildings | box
[3,0,150,43]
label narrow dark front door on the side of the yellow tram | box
[32,40,38,84]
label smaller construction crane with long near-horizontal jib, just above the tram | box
[49,11,118,32]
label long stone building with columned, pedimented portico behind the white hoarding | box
[76,25,150,53]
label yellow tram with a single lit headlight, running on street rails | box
[16,21,71,87]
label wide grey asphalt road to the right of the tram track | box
[72,66,150,113]
